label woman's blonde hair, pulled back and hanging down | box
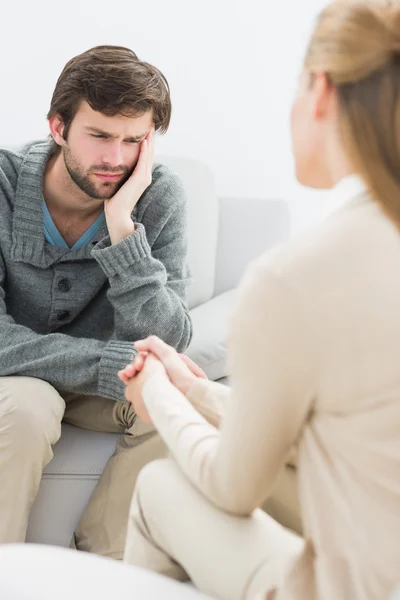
[305,0,400,227]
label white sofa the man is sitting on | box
[27,157,290,546]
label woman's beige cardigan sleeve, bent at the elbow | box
[143,263,315,515]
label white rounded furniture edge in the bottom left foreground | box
[0,544,216,600]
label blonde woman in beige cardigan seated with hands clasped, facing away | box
[121,0,400,600]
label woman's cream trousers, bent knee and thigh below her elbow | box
[124,459,304,600]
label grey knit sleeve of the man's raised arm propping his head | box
[92,169,192,352]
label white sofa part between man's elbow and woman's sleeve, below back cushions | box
[185,290,235,381]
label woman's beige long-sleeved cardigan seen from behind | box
[144,176,400,600]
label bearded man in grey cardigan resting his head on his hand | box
[0,46,192,558]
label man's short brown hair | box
[47,46,171,139]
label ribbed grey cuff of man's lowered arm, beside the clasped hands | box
[98,340,137,401]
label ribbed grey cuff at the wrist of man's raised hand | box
[92,223,151,277]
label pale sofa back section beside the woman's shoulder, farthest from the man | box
[214,198,290,295]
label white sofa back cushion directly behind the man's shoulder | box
[157,156,219,308]
